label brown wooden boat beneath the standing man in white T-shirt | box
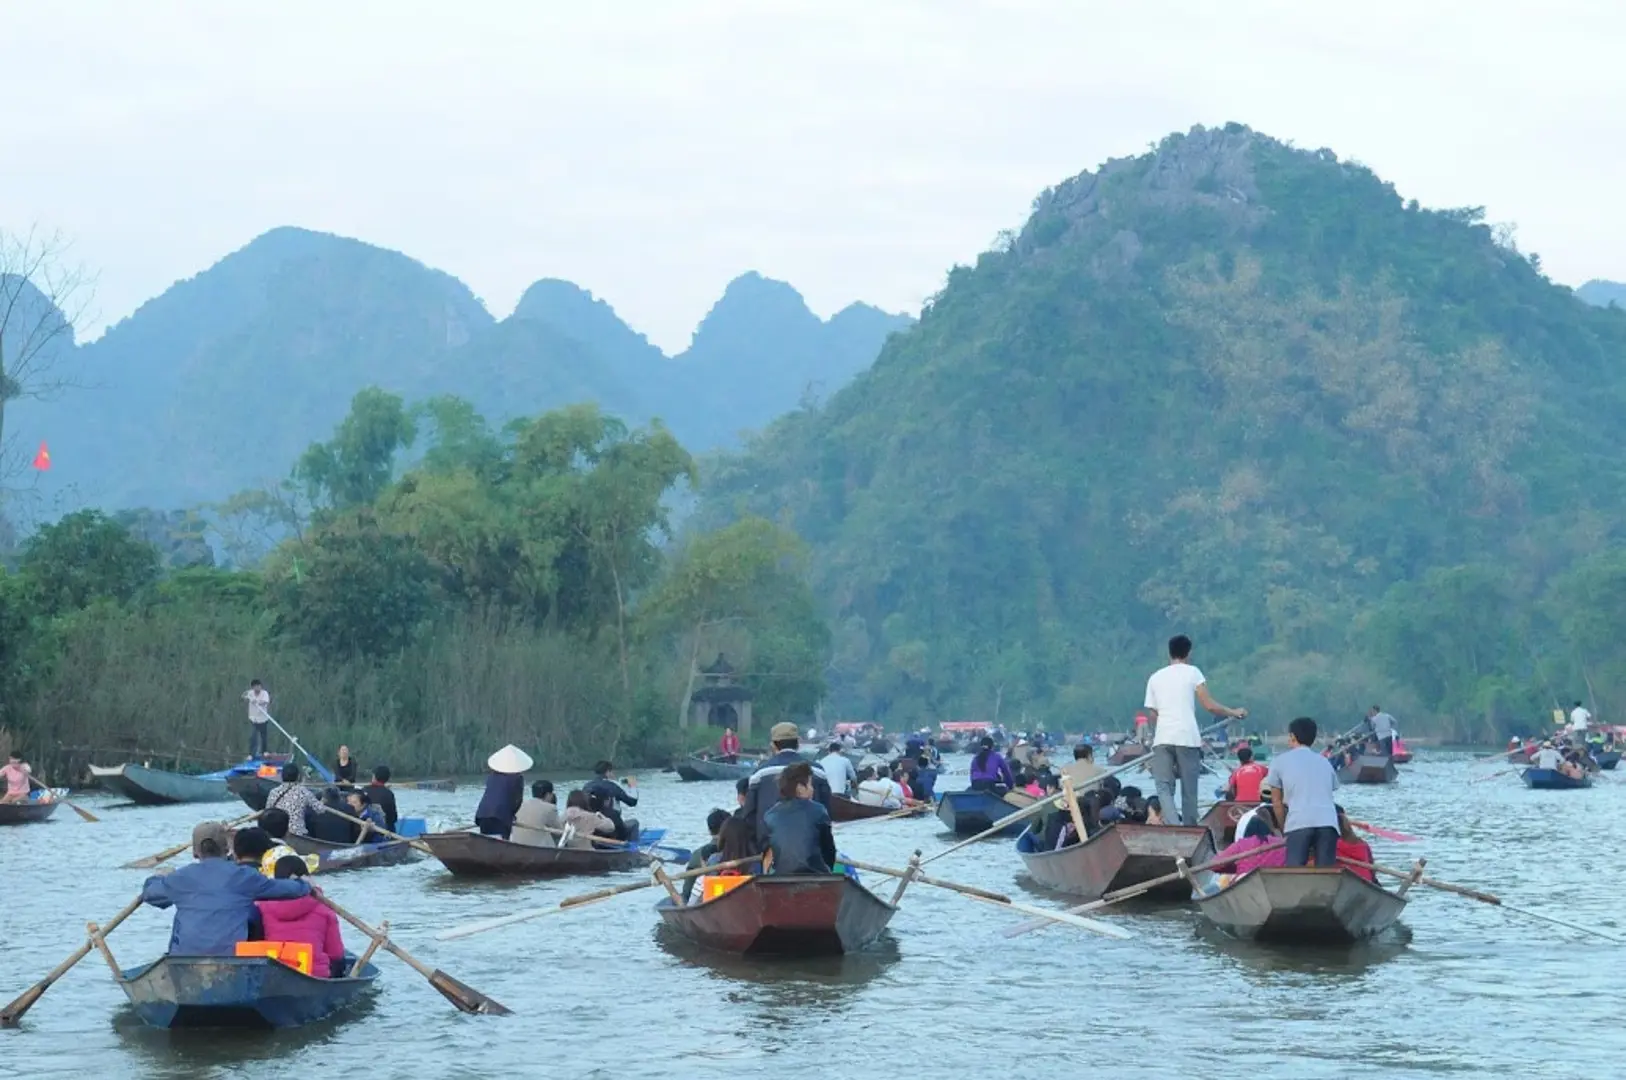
[1016,821,1215,901]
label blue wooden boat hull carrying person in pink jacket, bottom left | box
[119,956,379,1028]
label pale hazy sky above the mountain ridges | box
[0,0,1626,350]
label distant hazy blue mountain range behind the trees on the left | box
[7,228,911,516]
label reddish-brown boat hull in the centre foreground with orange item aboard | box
[655,873,898,956]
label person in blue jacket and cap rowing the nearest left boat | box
[141,821,311,956]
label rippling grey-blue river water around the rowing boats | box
[0,751,1626,1080]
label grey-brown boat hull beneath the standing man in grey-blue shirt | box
[1195,867,1406,945]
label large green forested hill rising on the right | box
[702,125,1626,732]
